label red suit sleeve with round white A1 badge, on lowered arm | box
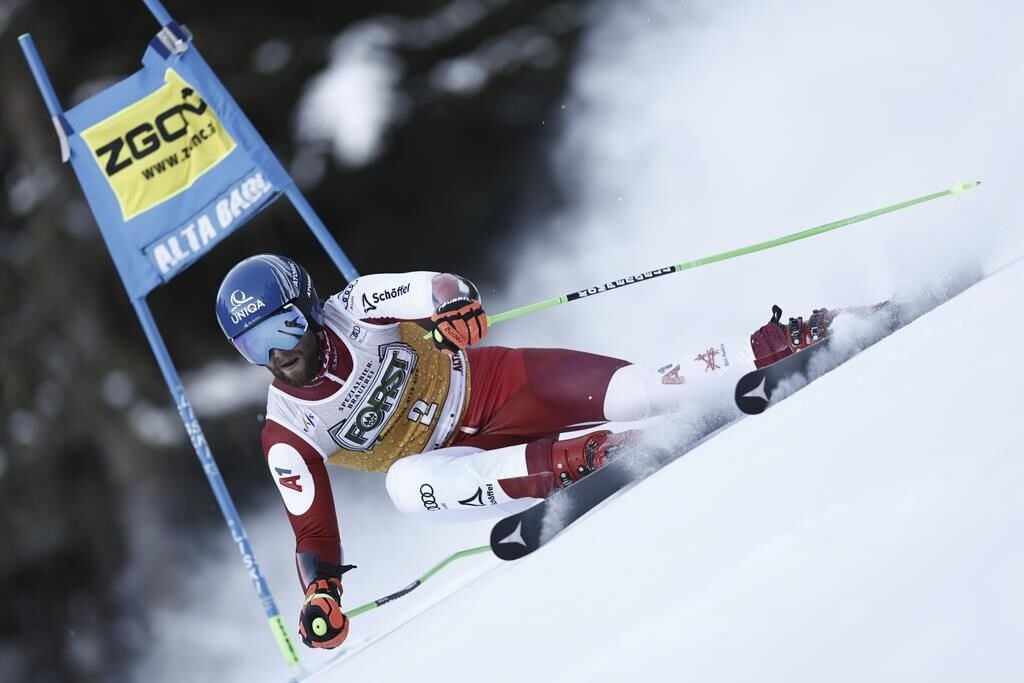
[262,420,341,588]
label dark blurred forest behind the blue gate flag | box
[0,0,599,681]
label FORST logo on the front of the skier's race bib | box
[328,344,418,451]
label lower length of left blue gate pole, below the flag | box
[132,299,299,668]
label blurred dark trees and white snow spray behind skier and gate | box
[0,0,1024,681]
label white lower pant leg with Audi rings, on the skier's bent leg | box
[386,445,541,521]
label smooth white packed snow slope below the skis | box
[317,263,1024,683]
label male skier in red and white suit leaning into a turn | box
[216,254,827,648]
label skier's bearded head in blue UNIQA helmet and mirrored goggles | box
[216,254,324,386]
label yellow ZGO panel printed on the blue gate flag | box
[82,69,234,220]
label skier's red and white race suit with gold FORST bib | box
[262,271,753,581]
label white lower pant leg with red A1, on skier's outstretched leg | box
[604,340,754,422]
